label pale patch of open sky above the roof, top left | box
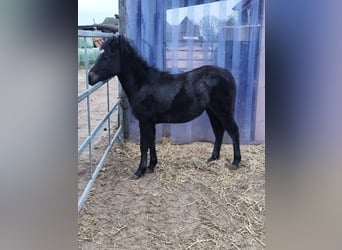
[78,0,119,25]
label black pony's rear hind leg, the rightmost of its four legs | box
[223,115,241,170]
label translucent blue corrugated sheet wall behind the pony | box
[126,0,262,143]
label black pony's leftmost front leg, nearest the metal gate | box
[135,121,154,178]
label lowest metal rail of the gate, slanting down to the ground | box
[77,124,123,212]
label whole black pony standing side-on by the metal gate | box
[88,36,241,178]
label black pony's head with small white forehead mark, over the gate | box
[88,36,122,85]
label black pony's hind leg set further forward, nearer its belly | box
[206,109,224,162]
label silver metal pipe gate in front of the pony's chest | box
[77,30,123,211]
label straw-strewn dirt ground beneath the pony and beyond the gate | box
[78,69,265,250]
